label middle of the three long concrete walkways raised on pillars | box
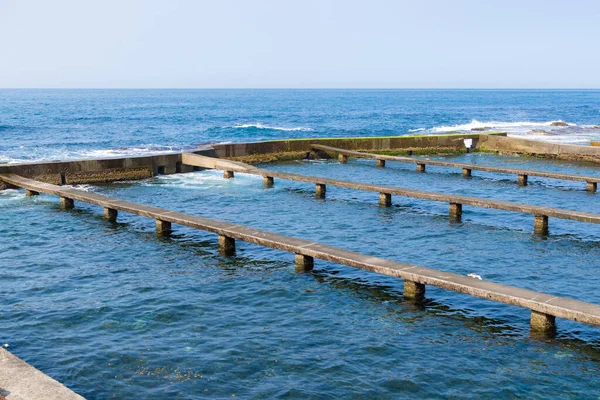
[180,156,600,228]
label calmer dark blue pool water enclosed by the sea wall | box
[0,153,600,399]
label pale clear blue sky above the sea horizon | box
[0,0,600,88]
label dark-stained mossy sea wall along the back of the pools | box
[0,135,492,190]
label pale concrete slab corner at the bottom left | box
[0,348,83,400]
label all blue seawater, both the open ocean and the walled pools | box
[0,90,600,399]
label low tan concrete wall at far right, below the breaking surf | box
[477,135,600,162]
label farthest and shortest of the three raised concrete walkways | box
[312,145,600,188]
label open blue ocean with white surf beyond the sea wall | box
[0,90,600,164]
